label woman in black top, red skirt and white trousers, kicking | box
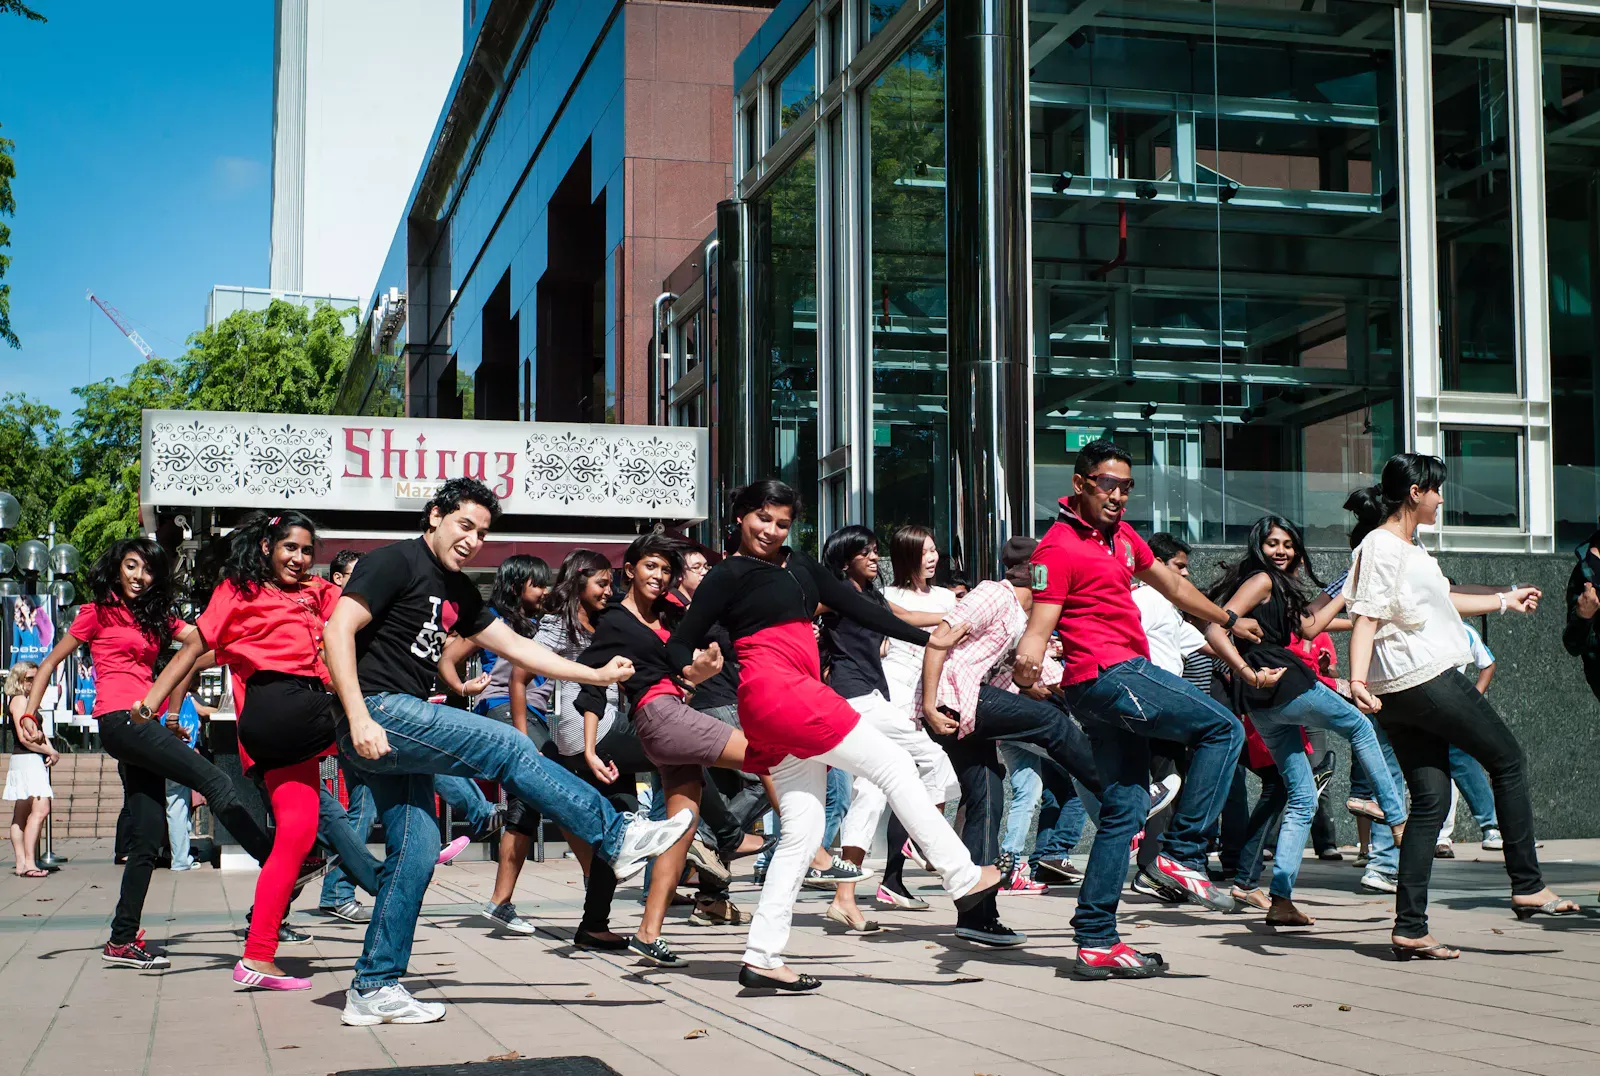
[667,480,1000,990]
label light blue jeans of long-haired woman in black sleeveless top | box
[1242,682,1405,900]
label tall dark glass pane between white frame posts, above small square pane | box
[1429,8,1517,392]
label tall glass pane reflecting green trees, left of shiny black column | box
[866,14,950,546]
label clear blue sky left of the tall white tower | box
[0,0,272,415]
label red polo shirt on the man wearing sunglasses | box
[1034,500,1155,684]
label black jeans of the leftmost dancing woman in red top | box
[101,709,272,945]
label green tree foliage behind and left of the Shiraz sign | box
[0,301,352,560]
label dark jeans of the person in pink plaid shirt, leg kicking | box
[933,685,1101,921]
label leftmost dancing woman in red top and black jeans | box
[27,538,272,969]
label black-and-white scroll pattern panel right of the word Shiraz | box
[523,432,696,512]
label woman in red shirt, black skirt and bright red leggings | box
[157,511,339,990]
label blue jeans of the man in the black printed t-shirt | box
[338,695,629,990]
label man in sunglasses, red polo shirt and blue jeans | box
[1016,440,1261,978]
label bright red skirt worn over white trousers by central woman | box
[734,620,861,773]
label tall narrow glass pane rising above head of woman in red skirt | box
[752,146,818,554]
